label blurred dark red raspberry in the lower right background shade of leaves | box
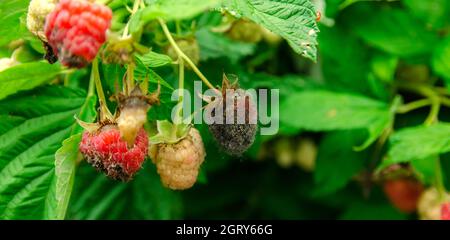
[384,179,423,213]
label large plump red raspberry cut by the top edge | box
[45,0,112,68]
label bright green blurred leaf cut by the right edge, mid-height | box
[384,123,450,164]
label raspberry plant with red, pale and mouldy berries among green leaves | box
[0,0,450,219]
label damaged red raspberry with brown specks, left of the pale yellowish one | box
[80,125,148,181]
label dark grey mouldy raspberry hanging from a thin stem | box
[207,77,257,156]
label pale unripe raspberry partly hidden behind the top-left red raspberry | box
[27,0,58,41]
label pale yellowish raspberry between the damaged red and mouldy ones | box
[149,128,205,190]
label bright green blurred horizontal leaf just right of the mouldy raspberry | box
[280,90,390,131]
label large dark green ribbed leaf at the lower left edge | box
[0,86,89,219]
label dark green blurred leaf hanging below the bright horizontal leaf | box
[314,131,367,195]
